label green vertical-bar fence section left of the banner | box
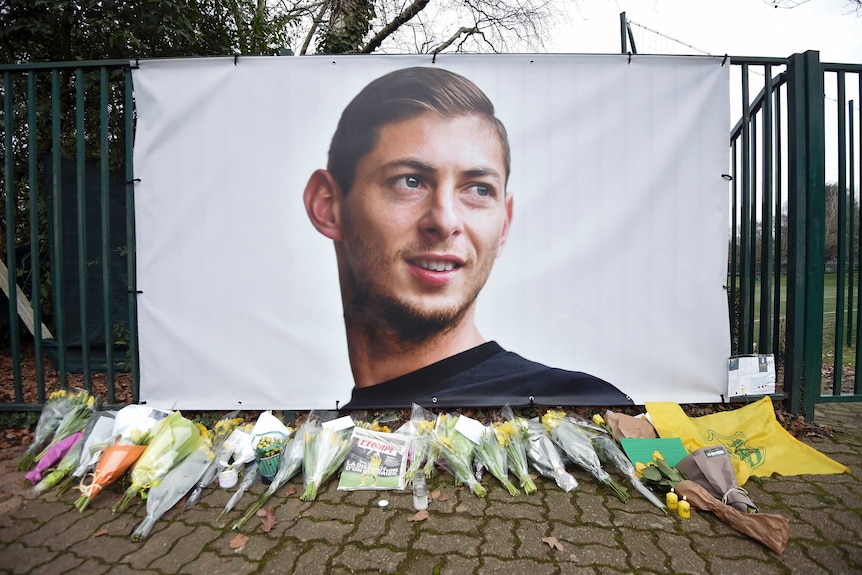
[0,60,139,410]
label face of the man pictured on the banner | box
[340,112,511,340]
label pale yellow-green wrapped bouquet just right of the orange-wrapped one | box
[113,411,202,512]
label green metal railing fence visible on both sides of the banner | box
[0,55,862,417]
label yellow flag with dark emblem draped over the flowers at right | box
[646,396,850,485]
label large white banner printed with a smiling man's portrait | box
[133,55,730,410]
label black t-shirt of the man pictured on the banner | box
[342,341,632,410]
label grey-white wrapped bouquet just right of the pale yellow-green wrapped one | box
[132,442,214,541]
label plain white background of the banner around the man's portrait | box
[133,51,730,410]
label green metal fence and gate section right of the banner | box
[728,52,862,417]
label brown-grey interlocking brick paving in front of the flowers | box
[0,403,862,575]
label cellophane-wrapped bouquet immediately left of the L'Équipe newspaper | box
[299,412,353,501]
